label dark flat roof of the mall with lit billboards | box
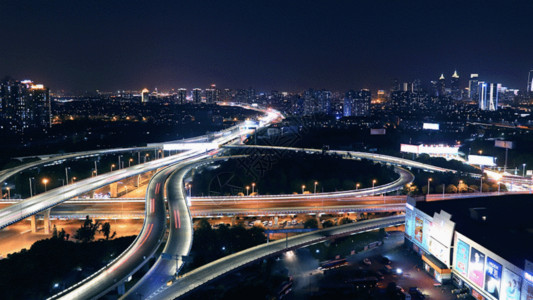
[416,194,533,268]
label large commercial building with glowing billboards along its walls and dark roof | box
[405,195,533,300]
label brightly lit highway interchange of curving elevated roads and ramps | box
[0,102,478,299]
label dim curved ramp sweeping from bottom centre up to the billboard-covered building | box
[157,215,405,299]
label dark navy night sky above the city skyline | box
[0,0,533,91]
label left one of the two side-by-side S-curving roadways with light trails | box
[53,166,167,299]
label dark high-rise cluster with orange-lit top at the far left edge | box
[0,78,52,133]
